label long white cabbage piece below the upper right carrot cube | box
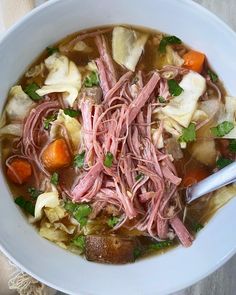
[162,72,206,128]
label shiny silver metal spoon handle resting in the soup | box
[186,162,236,204]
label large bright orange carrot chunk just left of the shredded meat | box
[42,138,71,171]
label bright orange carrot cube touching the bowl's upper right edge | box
[183,50,205,73]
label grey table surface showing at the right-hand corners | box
[0,0,236,295]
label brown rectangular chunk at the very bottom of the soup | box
[85,235,138,264]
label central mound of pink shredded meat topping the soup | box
[70,65,193,246]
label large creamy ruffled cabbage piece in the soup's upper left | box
[36,53,81,106]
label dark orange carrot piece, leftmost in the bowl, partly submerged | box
[7,159,32,184]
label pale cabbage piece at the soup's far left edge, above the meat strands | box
[5,85,35,121]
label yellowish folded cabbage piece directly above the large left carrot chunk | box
[50,110,81,149]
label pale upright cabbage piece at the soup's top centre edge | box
[112,27,148,72]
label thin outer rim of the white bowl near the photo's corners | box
[0,0,236,295]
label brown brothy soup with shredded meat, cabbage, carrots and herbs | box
[0,26,236,264]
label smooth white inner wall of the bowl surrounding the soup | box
[0,0,236,295]
